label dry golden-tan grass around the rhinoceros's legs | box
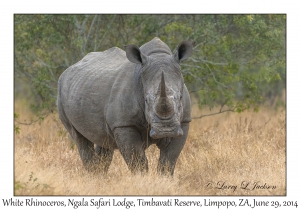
[14,101,286,195]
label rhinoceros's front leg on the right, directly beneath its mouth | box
[156,123,189,176]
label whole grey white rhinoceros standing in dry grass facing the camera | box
[57,38,192,175]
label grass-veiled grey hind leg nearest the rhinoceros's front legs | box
[95,145,114,173]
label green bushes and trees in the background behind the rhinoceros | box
[14,14,286,119]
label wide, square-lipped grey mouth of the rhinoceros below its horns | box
[149,126,183,139]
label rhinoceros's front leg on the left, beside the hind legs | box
[114,127,148,173]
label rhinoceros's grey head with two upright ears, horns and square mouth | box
[126,39,192,139]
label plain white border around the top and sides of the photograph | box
[0,0,300,209]
